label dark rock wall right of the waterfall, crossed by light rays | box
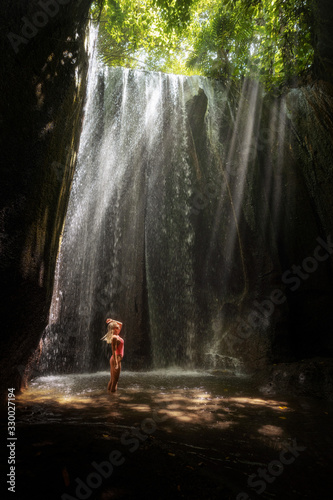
[219,82,333,367]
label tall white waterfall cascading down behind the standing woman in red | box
[41,34,246,372]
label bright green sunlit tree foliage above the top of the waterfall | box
[93,0,315,88]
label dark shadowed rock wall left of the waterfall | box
[0,0,91,402]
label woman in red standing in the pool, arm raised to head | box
[101,318,124,392]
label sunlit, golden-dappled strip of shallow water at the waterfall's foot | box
[19,370,292,435]
